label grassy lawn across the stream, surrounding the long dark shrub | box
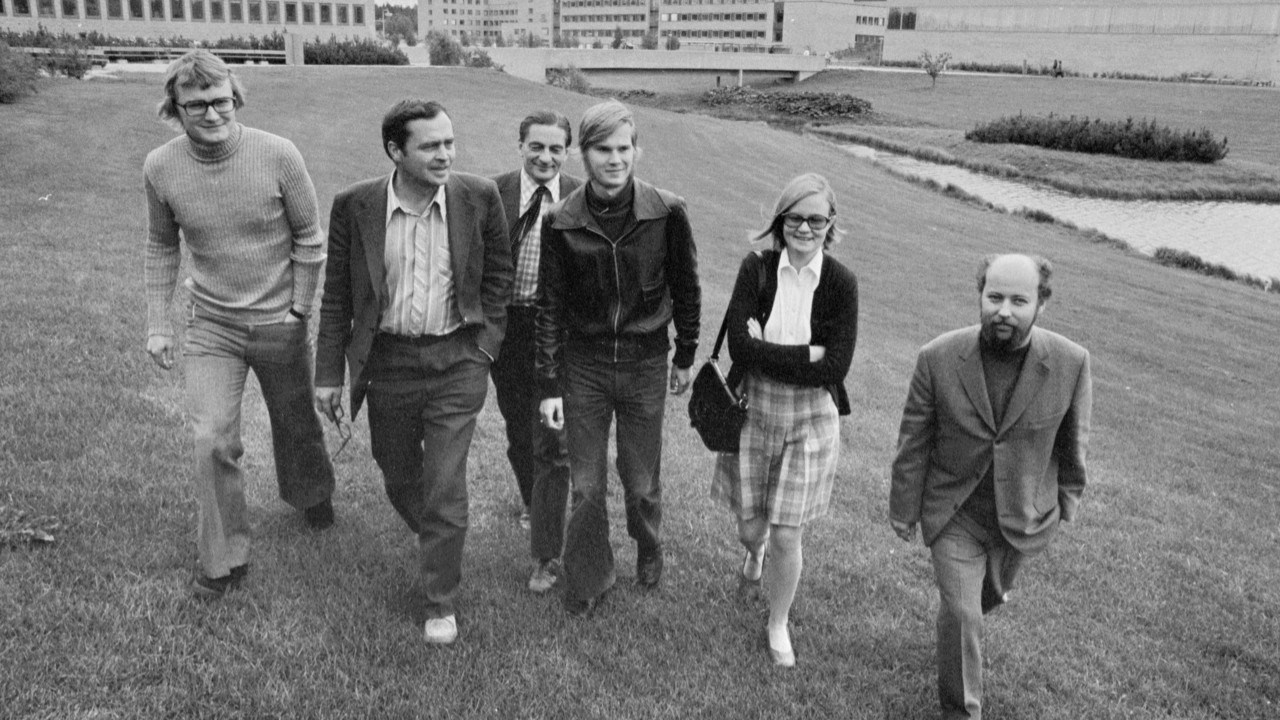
[645,70,1280,202]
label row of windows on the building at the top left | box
[0,0,365,26]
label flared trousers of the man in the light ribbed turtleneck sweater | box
[183,307,334,578]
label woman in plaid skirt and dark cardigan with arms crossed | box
[712,173,858,667]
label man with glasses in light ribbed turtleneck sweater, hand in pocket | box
[143,50,334,598]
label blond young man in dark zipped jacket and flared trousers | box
[535,100,701,615]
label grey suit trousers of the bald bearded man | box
[929,512,1025,720]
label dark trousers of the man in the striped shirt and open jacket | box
[366,331,489,618]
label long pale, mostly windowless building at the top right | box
[884,0,1280,83]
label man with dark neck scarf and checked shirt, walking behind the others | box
[493,110,582,593]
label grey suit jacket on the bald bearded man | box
[890,325,1093,553]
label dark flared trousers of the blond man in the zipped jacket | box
[563,351,667,600]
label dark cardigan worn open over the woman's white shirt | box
[727,250,858,415]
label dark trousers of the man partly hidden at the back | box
[493,305,568,560]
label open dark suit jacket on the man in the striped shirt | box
[316,172,512,418]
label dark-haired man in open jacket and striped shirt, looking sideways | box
[315,100,512,644]
